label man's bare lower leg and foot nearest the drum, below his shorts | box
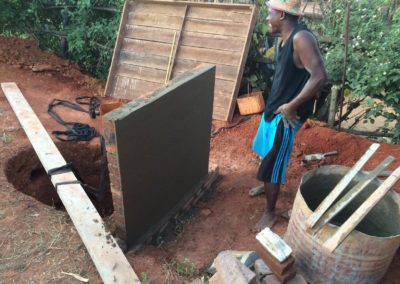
[257,182,280,231]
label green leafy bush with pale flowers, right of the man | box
[304,0,400,142]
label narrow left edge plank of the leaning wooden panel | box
[104,1,133,97]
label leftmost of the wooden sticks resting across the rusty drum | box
[306,143,380,228]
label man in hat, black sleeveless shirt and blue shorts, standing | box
[253,0,326,230]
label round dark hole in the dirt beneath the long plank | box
[5,142,113,217]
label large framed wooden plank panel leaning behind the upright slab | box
[105,0,257,121]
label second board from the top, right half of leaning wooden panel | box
[185,19,248,38]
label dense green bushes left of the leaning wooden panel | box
[0,0,124,79]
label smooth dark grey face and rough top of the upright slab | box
[106,66,215,247]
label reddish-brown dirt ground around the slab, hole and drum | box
[0,37,400,283]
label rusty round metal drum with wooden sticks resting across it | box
[285,166,400,284]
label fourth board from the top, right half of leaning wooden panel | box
[177,46,241,66]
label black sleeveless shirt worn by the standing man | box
[264,24,315,122]
